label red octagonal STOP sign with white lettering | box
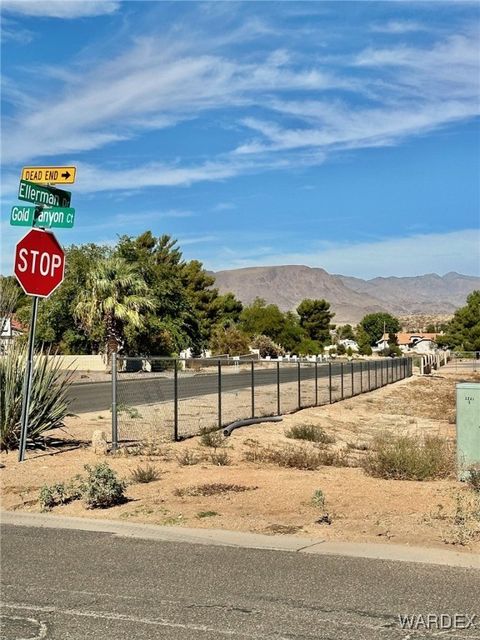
[14,229,65,298]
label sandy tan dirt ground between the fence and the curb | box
[0,371,480,552]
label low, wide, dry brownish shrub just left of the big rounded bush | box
[244,445,347,471]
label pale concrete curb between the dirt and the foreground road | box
[0,511,480,569]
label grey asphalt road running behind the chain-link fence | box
[69,361,392,414]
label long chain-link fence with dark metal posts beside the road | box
[112,357,412,447]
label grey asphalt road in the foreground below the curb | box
[1,526,480,640]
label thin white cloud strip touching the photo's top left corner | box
[1,0,120,20]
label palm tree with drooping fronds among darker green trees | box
[75,256,155,362]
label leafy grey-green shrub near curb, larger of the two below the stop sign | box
[80,462,127,509]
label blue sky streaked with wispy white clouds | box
[1,0,480,277]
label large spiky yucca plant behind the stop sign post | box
[0,341,73,450]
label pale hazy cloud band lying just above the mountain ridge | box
[205,229,480,278]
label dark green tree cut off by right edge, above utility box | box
[437,290,480,351]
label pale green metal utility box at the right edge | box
[457,382,480,480]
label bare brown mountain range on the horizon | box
[212,265,480,324]
